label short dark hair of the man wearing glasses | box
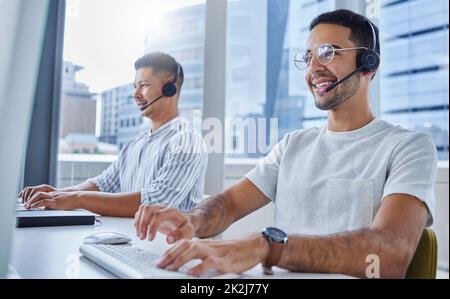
[309,9,380,55]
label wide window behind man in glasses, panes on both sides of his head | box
[225,0,449,160]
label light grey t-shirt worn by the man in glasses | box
[246,119,437,235]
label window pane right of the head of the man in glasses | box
[380,0,449,160]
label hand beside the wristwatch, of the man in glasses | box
[157,233,269,275]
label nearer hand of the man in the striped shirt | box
[25,191,80,210]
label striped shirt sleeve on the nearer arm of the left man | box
[141,131,208,208]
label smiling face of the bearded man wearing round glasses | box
[305,24,361,110]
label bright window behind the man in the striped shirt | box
[56,0,205,187]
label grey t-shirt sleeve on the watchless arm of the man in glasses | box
[245,134,290,201]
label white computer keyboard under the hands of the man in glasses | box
[80,244,219,279]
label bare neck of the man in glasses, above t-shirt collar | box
[328,94,375,132]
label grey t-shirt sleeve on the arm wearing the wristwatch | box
[383,133,437,226]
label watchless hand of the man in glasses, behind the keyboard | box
[134,205,195,244]
